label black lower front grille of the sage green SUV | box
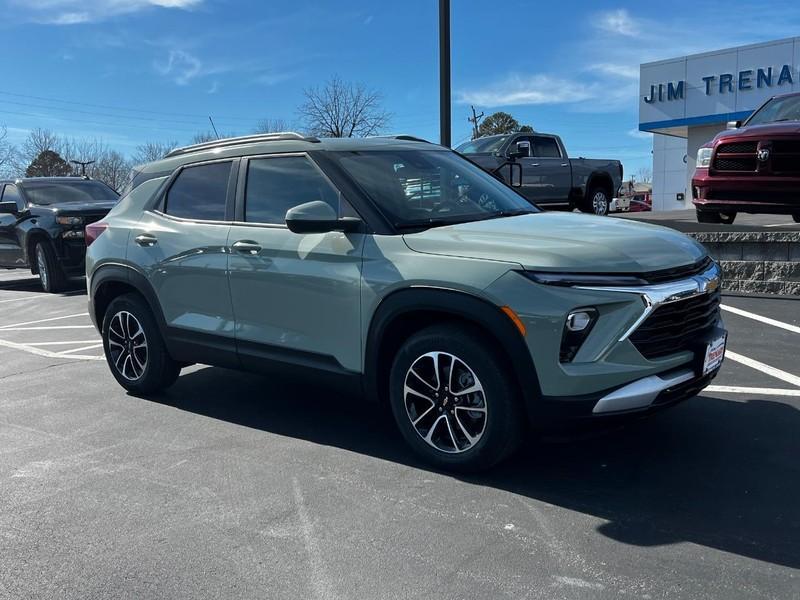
[630,290,720,359]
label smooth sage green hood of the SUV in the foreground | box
[403,212,706,273]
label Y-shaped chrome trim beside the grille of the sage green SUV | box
[575,263,722,342]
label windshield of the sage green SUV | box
[334,150,538,228]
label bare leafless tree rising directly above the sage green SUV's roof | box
[298,77,391,137]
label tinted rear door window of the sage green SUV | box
[164,162,231,221]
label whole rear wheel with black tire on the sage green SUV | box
[103,294,181,395]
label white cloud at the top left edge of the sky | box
[9,0,204,25]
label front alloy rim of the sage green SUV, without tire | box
[403,352,488,454]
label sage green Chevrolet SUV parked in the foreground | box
[86,133,726,470]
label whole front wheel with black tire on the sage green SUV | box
[389,325,524,472]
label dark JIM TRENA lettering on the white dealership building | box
[643,65,797,104]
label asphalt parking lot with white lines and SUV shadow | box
[0,271,800,600]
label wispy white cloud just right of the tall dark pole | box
[458,74,595,107]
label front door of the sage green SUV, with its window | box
[223,154,364,372]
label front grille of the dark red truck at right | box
[712,140,800,177]
